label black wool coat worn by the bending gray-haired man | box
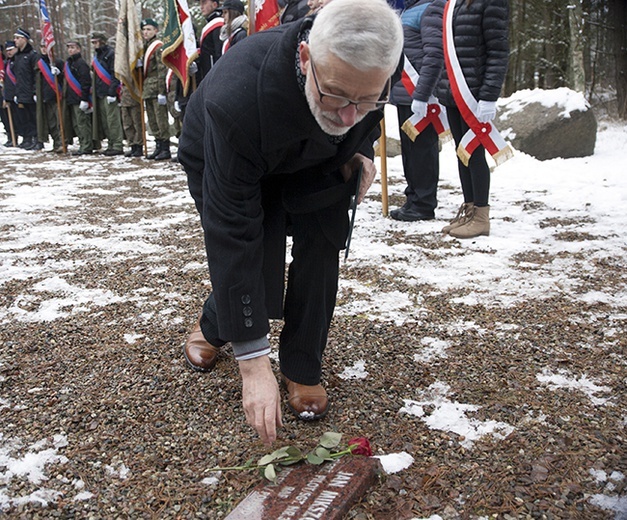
[178,18,400,341]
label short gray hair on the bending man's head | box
[309,0,403,74]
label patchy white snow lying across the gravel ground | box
[0,95,627,520]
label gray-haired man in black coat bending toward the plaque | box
[179,0,403,443]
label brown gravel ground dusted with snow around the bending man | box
[0,140,627,520]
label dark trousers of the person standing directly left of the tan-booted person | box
[396,105,440,215]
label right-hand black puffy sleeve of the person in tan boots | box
[478,0,509,101]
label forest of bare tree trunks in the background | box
[0,0,627,120]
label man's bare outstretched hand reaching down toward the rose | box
[239,356,283,445]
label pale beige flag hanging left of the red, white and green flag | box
[114,0,144,101]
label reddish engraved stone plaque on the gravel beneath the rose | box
[226,456,381,520]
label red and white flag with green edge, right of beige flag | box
[161,0,198,95]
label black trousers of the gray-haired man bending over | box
[200,179,349,385]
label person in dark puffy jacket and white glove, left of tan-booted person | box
[390,0,446,222]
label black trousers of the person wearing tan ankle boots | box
[446,107,490,207]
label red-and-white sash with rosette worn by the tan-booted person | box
[444,0,513,166]
